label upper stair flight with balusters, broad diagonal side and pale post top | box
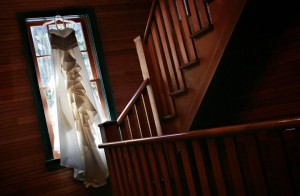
[134,0,246,134]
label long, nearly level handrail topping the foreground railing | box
[98,117,300,148]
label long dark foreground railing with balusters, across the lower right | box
[99,118,300,196]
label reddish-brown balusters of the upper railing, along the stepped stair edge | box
[135,0,213,119]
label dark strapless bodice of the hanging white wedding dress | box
[49,28,78,51]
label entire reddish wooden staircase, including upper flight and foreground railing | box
[99,0,300,196]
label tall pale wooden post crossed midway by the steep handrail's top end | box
[133,36,162,135]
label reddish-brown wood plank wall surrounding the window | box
[0,0,151,195]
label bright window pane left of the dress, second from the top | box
[37,56,52,87]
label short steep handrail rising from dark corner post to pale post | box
[117,78,149,124]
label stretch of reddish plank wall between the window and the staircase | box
[97,2,150,114]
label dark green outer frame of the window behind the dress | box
[17,8,117,171]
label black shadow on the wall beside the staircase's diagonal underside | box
[191,0,299,130]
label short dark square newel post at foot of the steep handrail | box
[98,121,121,143]
